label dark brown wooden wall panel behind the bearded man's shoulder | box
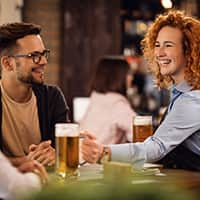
[60,0,121,120]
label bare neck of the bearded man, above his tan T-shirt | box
[1,79,32,103]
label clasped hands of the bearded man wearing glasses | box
[27,140,55,166]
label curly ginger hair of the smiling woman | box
[141,10,200,89]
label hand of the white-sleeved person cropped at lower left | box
[18,160,48,183]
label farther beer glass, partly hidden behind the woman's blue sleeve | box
[133,116,153,142]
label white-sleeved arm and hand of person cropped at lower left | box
[0,151,48,200]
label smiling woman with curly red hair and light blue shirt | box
[82,11,200,170]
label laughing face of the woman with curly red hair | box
[154,26,186,83]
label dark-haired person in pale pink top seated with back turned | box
[80,56,136,144]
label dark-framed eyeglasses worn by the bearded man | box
[8,49,50,64]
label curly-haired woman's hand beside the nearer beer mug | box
[81,133,103,163]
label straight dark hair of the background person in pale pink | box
[91,56,129,95]
